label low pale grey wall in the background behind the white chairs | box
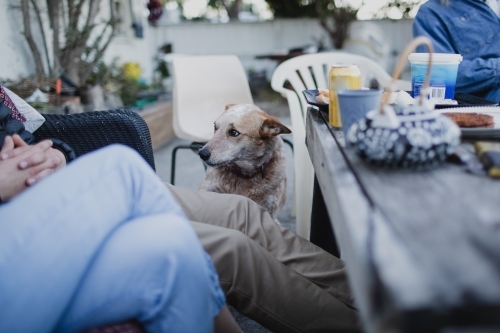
[150,19,413,76]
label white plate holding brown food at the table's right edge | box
[436,106,500,138]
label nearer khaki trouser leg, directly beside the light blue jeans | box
[192,222,359,333]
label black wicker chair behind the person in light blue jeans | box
[33,110,149,333]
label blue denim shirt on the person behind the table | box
[413,0,500,102]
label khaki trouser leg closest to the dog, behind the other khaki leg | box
[168,185,355,307]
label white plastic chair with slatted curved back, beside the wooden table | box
[271,52,411,239]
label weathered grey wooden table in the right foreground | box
[306,108,500,333]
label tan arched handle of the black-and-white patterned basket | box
[380,36,434,113]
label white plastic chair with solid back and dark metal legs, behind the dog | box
[170,55,253,184]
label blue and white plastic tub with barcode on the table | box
[408,53,463,99]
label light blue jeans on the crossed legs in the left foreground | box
[0,146,225,333]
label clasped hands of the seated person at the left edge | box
[0,135,63,202]
